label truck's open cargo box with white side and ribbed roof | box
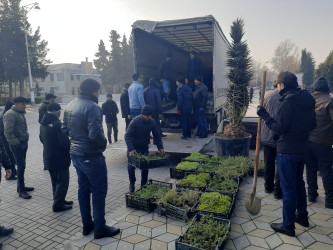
[132,15,230,132]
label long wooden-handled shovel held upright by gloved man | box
[245,71,266,215]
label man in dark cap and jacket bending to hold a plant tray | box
[125,105,164,192]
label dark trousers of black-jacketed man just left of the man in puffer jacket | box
[49,168,69,209]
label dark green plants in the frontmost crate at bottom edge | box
[181,216,230,250]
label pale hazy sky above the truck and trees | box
[22,0,333,65]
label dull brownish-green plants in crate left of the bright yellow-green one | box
[158,189,200,209]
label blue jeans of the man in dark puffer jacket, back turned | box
[71,155,108,230]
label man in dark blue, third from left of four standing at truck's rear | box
[176,78,193,140]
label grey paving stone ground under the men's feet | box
[0,95,333,250]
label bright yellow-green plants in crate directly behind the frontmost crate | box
[198,192,232,214]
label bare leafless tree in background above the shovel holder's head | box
[272,39,300,73]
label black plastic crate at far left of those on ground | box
[125,180,172,212]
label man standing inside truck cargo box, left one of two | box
[158,52,172,101]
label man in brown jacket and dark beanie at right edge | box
[306,78,333,209]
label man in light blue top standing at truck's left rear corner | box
[128,73,145,119]
